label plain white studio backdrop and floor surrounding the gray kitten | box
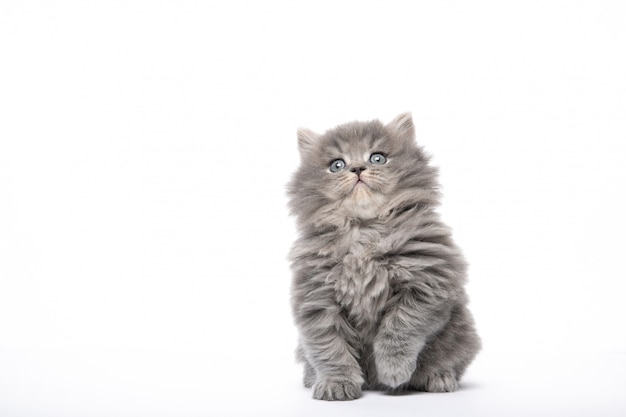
[0,0,626,417]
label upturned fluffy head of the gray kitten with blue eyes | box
[288,113,437,227]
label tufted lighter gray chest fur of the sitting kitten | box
[333,228,389,324]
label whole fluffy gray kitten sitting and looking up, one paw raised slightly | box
[288,113,480,400]
